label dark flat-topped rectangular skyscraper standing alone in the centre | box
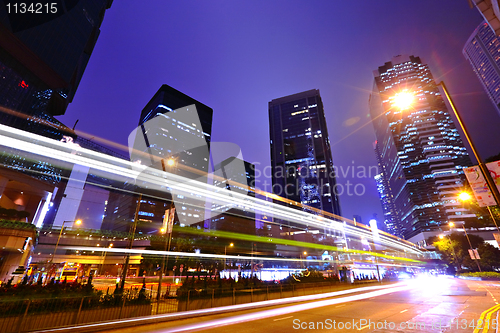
[269,89,340,215]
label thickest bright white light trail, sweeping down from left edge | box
[0,125,424,256]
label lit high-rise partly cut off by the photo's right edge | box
[462,22,500,113]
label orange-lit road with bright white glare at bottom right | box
[95,277,500,333]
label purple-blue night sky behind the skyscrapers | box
[58,0,500,226]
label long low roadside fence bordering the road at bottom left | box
[0,282,379,333]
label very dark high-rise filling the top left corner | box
[0,0,112,140]
